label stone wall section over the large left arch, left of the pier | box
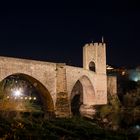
[0,57,56,104]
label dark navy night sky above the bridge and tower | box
[0,0,140,67]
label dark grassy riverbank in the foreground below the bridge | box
[0,117,139,140]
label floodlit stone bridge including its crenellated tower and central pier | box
[0,43,115,117]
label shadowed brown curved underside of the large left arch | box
[1,73,54,114]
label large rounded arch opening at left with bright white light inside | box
[0,73,54,117]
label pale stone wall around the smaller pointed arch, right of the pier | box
[66,66,107,105]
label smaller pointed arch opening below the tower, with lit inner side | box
[70,75,95,116]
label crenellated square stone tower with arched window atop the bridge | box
[83,43,106,74]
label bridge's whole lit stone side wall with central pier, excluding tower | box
[0,57,108,117]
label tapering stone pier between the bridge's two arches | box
[55,64,70,117]
